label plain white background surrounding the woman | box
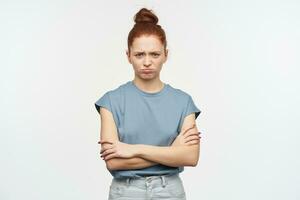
[0,0,300,200]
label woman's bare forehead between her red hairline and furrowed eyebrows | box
[131,35,164,51]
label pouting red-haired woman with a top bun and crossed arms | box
[95,8,201,200]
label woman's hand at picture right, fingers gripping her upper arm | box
[171,124,201,146]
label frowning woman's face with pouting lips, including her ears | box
[126,35,168,80]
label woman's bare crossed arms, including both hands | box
[98,107,200,170]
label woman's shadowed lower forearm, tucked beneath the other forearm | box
[106,157,158,170]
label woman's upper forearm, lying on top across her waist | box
[135,144,199,167]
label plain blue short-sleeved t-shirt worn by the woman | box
[95,81,201,178]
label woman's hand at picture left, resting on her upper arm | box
[99,140,136,160]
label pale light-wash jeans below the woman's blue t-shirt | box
[108,174,186,200]
